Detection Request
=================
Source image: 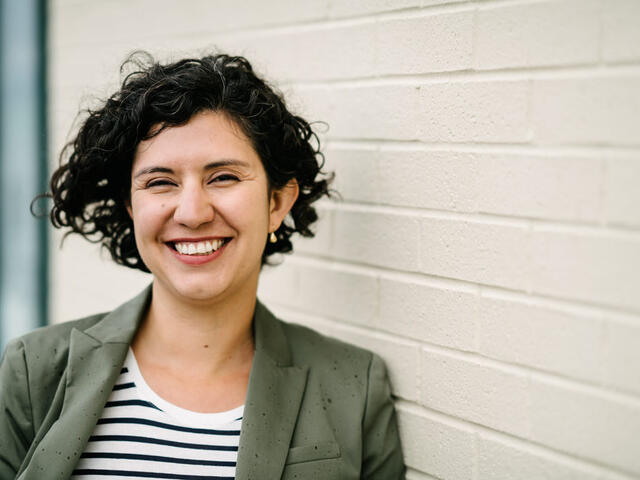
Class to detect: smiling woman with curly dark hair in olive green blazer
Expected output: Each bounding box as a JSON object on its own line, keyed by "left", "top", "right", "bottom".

{"left": 0, "top": 55, "right": 404, "bottom": 480}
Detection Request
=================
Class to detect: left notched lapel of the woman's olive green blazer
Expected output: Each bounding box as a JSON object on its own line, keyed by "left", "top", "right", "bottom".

{"left": 18, "top": 288, "right": 150, "bottom": 480}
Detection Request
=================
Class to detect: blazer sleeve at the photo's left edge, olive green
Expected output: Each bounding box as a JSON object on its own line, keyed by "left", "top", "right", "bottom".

{"left": 0, "top": 340, "right": 34, "bottom": 480}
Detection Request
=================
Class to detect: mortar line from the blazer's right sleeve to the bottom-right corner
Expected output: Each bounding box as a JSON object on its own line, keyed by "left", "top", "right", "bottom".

{"left": 395, "top": 399, "right": 637, "bottom": 480}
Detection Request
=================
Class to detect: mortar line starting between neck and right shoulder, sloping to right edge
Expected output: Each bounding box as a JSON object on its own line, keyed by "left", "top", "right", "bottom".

{"left": 273, "top": 301, "right": 640, "bottom": 409}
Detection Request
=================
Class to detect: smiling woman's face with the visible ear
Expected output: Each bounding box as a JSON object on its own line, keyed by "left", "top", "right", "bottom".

{"left": 128, "top": 111, "right": 298, "bottom": 302}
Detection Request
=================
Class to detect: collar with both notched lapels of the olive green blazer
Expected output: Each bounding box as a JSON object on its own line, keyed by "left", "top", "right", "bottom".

{"left": 18, "top": 286, "right": 307, "bottom": 480}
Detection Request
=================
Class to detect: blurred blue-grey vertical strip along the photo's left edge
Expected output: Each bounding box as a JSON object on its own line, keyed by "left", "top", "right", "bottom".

{"left": 0, "top": 0, "right": 47, "bottom": 346}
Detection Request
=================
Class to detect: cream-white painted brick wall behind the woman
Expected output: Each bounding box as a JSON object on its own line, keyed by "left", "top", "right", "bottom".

{"left": 49, "top": 0, "right": 640, "bottom": 480}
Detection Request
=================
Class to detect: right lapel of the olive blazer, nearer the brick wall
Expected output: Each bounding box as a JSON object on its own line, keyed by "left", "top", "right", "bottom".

{"left": 236, "top": 302, "right": 308, "bottom": 480}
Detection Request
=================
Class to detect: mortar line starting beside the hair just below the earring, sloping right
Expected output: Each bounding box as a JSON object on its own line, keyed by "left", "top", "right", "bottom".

{"left": 290, "top": 252, "right": 640, "bottom": 327}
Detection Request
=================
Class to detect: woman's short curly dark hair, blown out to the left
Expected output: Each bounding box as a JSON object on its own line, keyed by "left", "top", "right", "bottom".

{"left": 45, "top": 52, "right": 331, "bottom": 272}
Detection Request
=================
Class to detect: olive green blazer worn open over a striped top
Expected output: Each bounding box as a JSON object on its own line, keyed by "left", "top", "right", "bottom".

{"left": 0, "top": 288, "right": 404, "bottom": 480}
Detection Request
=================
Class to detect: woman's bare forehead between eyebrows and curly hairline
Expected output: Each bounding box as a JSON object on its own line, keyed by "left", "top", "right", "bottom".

{"left": 133, "top": 110, "right": 261, "bottom": 169}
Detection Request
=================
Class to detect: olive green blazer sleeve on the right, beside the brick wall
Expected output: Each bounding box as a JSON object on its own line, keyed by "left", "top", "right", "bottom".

{"left": 362, "top": 354, "right": 405, "bottom": 480}
